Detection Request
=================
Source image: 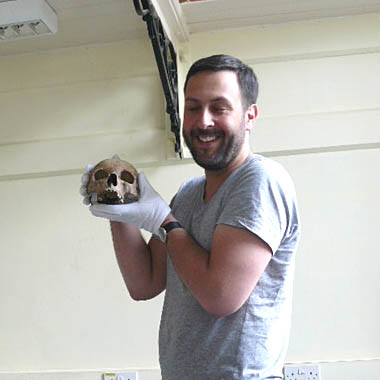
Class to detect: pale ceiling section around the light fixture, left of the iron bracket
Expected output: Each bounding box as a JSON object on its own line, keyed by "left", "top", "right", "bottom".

{"left": 0, "top": 0, "right": 147, "bottom": 56}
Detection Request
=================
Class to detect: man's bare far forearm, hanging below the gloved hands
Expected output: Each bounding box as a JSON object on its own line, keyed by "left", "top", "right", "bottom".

{"left": 111, "top": 222, "right": 166, "bottom": 300}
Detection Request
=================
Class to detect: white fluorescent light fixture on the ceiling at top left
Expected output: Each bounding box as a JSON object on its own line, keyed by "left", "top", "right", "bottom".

{"left": 0, "top": 0, "right": 57, "bottom": 42}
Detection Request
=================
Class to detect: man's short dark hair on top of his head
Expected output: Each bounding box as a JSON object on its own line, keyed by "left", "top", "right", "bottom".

{"left": 184, "top": 54, "right": 259, "bottom": 109}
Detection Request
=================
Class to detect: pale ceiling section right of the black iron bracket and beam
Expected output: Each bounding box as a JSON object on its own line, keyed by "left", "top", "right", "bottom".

{"left": 182, "top": 0, "right": 380, "bottom": 33}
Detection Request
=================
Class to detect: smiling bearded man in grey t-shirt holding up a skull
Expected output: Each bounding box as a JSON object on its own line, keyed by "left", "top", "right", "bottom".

{"left": 81, "top": 55, "right": 299, "bottom": 380}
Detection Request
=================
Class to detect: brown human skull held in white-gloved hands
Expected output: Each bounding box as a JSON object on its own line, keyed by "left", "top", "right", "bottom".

{"left": 87, "top": 157, "right": 139, "bottom": 205}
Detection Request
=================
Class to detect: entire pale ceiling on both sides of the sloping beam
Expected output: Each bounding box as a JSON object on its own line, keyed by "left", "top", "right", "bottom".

{"left": 0, "top": 0, "right": 380, "bottom": 56}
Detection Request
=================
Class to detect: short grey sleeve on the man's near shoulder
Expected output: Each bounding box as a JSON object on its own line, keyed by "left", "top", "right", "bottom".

{"left": 217, "top": 161, "right": 294, "bottom": 254}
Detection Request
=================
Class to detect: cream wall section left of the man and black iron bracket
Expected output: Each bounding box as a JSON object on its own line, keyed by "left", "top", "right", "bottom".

{"left": 0, "top": 37, "right": 175, "bottom": 378}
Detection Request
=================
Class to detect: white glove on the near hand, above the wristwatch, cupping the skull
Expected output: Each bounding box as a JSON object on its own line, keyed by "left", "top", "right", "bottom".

{"left": 90, "top": 173, "right": 171, "bottom": 234}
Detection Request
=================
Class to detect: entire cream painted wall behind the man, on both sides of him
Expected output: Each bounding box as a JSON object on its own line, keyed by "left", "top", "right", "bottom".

{"left": 0, "top": 10, "right": 380, "bottom": 380}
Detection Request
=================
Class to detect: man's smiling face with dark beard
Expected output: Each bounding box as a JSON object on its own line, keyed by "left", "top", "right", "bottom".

{"left": 183, "top": 71, "right": 248, "bottom": 170}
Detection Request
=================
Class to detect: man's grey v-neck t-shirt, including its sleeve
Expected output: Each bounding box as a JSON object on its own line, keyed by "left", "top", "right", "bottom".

{"left": 159, "top": 155, "right": 299, "bottom": 380}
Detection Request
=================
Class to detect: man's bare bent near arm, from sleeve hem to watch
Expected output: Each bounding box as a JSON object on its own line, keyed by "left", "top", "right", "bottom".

{"left": 168, "top": 215, "right": 272, "bottom": 317}
